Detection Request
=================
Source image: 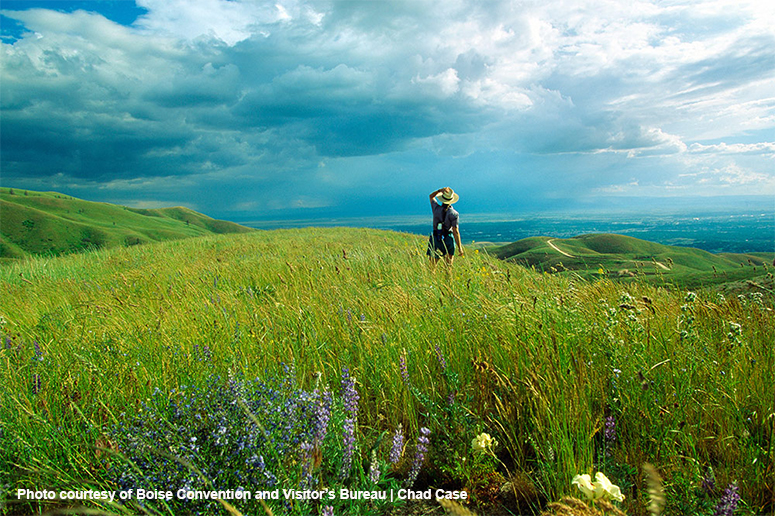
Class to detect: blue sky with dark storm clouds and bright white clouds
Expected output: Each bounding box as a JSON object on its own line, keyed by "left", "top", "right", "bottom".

{"left": 0, "top": 0, "right": 775, "bottom": 221}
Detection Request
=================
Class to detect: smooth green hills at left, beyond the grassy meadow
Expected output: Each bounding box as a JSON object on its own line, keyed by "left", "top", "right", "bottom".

{"left": 0, "top": 188, "right": 252, "bottom": 260}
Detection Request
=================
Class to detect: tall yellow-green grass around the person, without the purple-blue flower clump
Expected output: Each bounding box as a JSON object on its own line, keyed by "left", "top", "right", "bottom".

{"left": 0, "top": 229, "right": 775, "bottom": 513}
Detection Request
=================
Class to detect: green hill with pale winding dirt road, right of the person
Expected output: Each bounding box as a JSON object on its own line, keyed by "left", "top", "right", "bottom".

{"left": 486, "top": 234, "right": 775, "bottom": 288}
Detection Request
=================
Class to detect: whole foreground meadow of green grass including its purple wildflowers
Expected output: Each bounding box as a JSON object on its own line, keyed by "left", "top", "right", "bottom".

{"left": 0, "top": 228, "right": 775, "bottom": 515}
